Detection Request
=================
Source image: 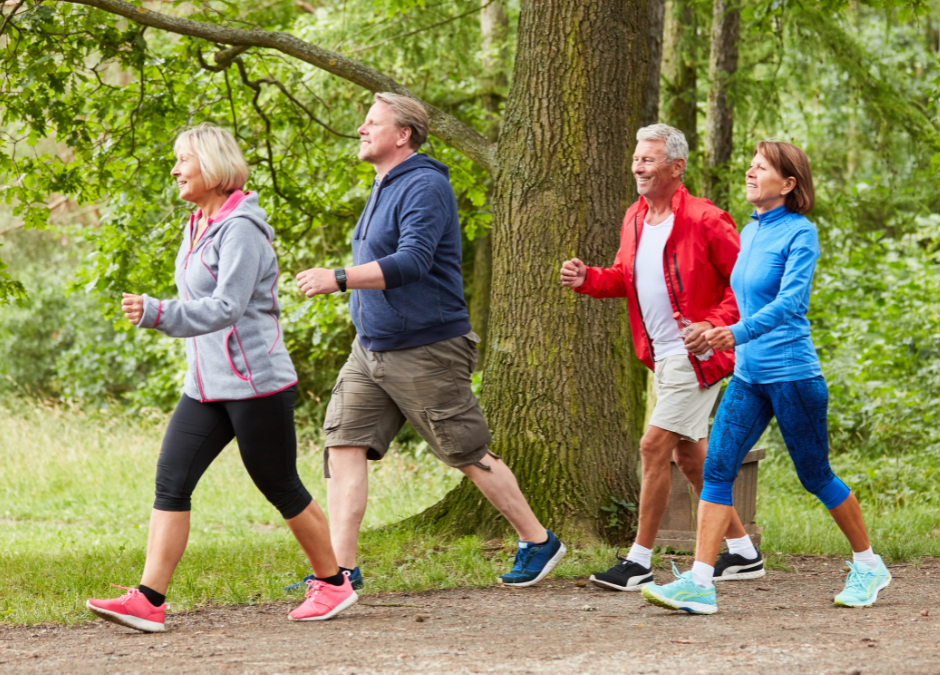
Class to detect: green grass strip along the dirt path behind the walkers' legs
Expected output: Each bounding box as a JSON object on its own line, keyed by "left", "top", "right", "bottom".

{"left": 0, "top": 402, "right": 940, "bottom": 624}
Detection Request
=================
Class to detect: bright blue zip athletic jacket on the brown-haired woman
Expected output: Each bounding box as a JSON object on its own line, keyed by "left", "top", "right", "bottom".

{"left": 729, "top": 206, "right": 822, "bottom": 384}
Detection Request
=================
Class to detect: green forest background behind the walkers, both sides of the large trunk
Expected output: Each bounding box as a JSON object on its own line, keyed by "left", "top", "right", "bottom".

{"left": 0, "top": 0, "right": 940, "bottom": 624}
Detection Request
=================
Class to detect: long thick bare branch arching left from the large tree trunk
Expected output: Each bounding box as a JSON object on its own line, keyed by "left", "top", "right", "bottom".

{"left": 58, "top": 0, "right": 496, "bottom": 173}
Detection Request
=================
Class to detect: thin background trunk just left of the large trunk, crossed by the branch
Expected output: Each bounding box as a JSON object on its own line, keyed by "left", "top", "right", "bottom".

{"left": 470, "top": 0, "right": 509, "bottom": 369}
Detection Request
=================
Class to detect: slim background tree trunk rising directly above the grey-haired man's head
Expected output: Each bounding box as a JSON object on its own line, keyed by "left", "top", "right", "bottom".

{"left": 659, "top": 0, "right": 698, "bottom": 154}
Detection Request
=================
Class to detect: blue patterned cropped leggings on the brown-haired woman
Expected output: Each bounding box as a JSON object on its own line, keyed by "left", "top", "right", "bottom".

{"left": 701, "top": 376, "right": 851, "bottom": 509}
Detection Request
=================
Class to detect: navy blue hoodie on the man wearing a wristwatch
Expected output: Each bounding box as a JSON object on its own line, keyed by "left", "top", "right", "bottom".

{"left": 349, "top": 154, "right": 470, "bottom": 352}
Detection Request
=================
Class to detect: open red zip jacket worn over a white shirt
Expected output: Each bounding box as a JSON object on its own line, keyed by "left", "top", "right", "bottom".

{"left": 575, "top": 185, "right": 741, "bottom": 388}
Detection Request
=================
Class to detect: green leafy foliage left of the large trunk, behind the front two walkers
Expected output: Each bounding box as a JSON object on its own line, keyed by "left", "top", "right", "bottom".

{"left": 0, "top": 0, "right": 500, "bottom": 416}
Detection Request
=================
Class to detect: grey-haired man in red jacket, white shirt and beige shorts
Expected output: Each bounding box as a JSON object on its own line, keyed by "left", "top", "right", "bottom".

{"left": 561, "top": 124, "right": 764, "bottom": 591}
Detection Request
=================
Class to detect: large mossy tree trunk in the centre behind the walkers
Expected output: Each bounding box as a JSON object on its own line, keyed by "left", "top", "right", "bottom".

{"left": 419, "top": 0, "right": 647, "bottom": 542}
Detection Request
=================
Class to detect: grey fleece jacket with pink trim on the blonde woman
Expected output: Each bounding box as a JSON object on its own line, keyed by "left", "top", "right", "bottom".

{"left": 138, "top": 190, "right": 297, "bottom": 402}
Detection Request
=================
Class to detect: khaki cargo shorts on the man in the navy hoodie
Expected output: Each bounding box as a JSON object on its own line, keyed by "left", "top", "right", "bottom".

{"left": 323, "top": 333, "right": 495, "bottom": 478}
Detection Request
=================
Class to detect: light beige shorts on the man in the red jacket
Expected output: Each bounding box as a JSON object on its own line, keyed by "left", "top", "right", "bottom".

{"left": 650, "top": 355, "right": 721, "bottom": 443}
